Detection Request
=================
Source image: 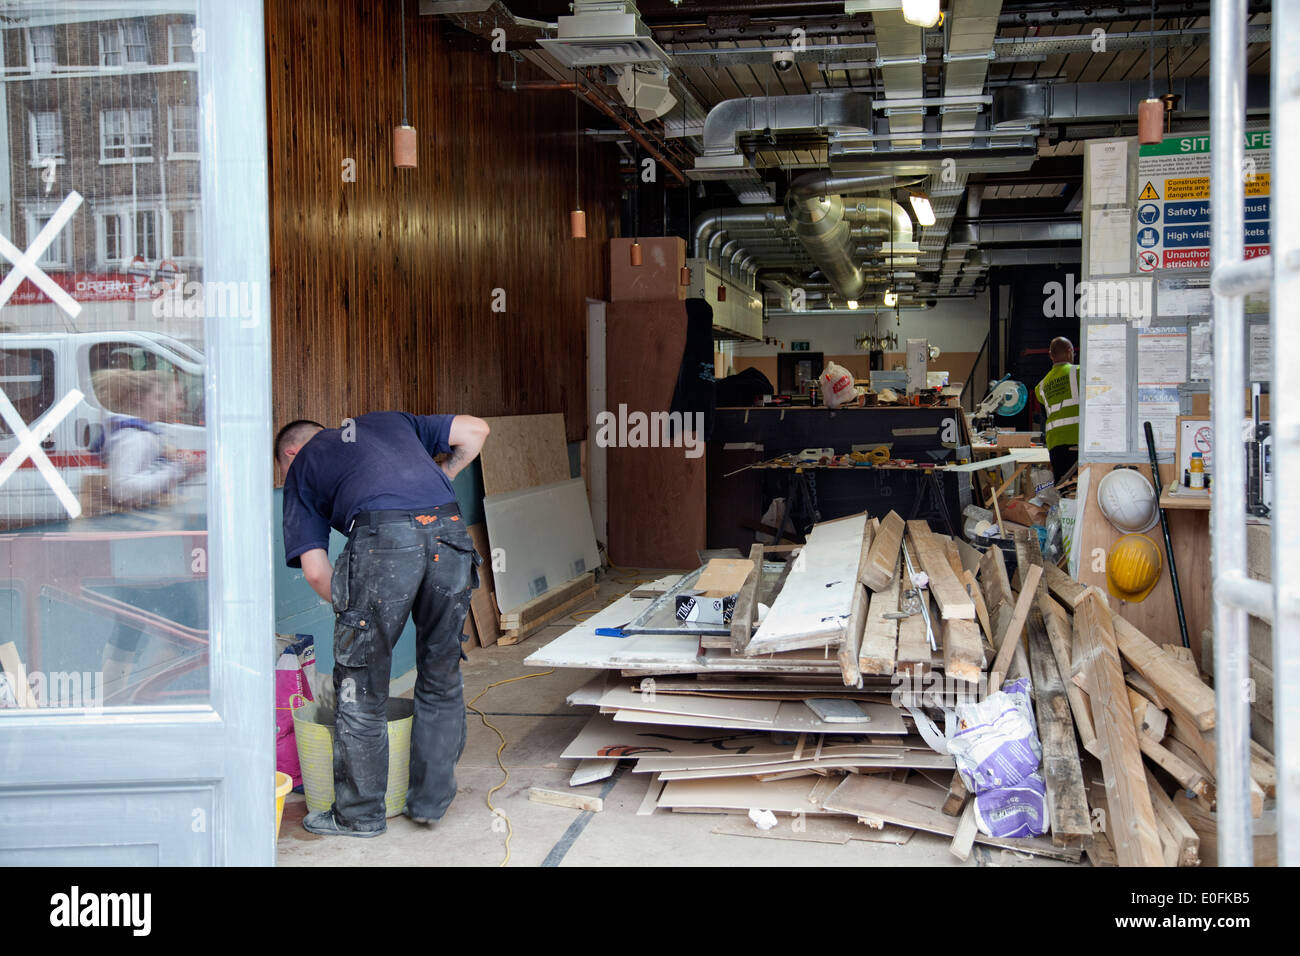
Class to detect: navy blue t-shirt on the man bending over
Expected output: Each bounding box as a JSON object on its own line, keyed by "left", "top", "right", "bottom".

{"left": 285, "top": 411, "right": 456, "bottom": 567}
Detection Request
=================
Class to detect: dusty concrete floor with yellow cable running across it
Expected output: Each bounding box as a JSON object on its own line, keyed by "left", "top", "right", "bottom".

{"left": 271, "top": 580, "right": 1066, "bottom": 866}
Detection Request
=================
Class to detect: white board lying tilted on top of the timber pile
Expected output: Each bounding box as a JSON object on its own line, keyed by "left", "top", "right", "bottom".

{"left": 746, "top": 515, "right": 867, "bottom": 654}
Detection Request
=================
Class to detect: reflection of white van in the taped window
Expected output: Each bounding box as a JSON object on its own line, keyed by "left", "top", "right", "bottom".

{"left": 0, "top": 332, "right": 207, "bottom": 528}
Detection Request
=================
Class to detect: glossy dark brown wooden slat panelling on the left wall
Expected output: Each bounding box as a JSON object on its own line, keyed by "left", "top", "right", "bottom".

{"left": 265, "top": 0, "right": 616, "bottom": 441}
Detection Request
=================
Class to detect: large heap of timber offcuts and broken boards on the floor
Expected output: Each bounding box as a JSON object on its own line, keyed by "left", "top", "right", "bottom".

{"left": 525, "top": 512, "right": 1271, "bottom": 865}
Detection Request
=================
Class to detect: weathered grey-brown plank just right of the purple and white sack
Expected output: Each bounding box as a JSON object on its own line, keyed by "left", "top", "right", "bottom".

{"left": 1027, "top": 607, "right": 1092, "bottom": 847}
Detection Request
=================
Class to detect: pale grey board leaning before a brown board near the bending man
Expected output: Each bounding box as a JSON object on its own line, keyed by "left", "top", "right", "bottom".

{"left": 484, "top": 479, "right": 601, "bottom": 614}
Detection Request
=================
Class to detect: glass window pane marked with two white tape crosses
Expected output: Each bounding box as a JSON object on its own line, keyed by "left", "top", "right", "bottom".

{"left": 0, "top": 3, "right": 209, "bottom": 718}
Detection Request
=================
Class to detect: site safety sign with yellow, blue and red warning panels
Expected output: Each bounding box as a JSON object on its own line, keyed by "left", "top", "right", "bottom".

{"left": 1134, "top": 130, "right": 1273, "bottom": 272}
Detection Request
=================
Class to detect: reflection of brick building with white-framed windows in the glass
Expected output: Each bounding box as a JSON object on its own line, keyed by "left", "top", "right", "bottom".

{"left": 0, "top": 13, "right": 202, "bottom": 304}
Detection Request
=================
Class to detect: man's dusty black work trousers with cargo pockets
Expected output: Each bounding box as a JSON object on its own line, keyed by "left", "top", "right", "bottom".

{"left": 330, "top": 505, "right": 481, "bottom": 830}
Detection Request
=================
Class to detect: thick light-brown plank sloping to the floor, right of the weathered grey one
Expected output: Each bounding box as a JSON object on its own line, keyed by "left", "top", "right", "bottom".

{"left": 1071, "top": 590, "right": 1164, "bottom": 866}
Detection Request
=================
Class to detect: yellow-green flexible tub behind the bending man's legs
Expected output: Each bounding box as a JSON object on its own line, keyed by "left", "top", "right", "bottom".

{"left": 294, "top": 697, "right": 415, "bottom": 817}
